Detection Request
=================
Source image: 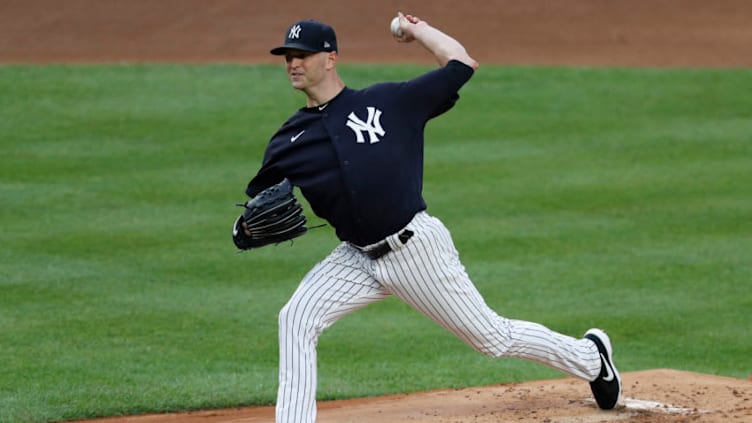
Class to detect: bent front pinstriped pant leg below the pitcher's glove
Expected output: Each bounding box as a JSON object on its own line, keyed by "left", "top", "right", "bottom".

{"left": 276, "top": 244, "right": 389, "bottom": 423}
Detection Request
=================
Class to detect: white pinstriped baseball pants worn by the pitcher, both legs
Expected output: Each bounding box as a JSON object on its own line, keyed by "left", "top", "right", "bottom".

{"left": 276, "top": 212, "right": 601, "bottom": 423}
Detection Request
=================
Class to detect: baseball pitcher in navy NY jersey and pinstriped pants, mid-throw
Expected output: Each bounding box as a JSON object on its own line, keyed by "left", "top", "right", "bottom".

{"left": 233, "top": 13, "right": 621, "bottom": 423}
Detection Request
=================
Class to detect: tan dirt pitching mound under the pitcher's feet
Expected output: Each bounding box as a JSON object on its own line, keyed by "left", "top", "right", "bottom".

{"left": 78, "top": 369, "right": 752, "bottom": 423}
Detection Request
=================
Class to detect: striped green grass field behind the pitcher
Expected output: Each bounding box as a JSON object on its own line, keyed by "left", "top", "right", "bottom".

{"left": 0, "top": 65, "right": 752, "bottom": 423}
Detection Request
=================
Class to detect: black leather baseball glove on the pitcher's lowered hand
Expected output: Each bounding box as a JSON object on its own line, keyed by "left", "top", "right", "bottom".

{"left": 232, "top": 179, "right": 308, "bottom": 250}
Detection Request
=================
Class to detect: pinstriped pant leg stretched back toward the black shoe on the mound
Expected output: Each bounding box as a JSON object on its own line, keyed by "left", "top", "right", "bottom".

{"left": 376, "top": 213, "right": 601, "bottom": 380}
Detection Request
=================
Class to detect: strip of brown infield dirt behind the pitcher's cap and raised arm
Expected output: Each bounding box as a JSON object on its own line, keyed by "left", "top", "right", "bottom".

{"left": 0, "top": 0, "right": 752, "bottom": 67}
